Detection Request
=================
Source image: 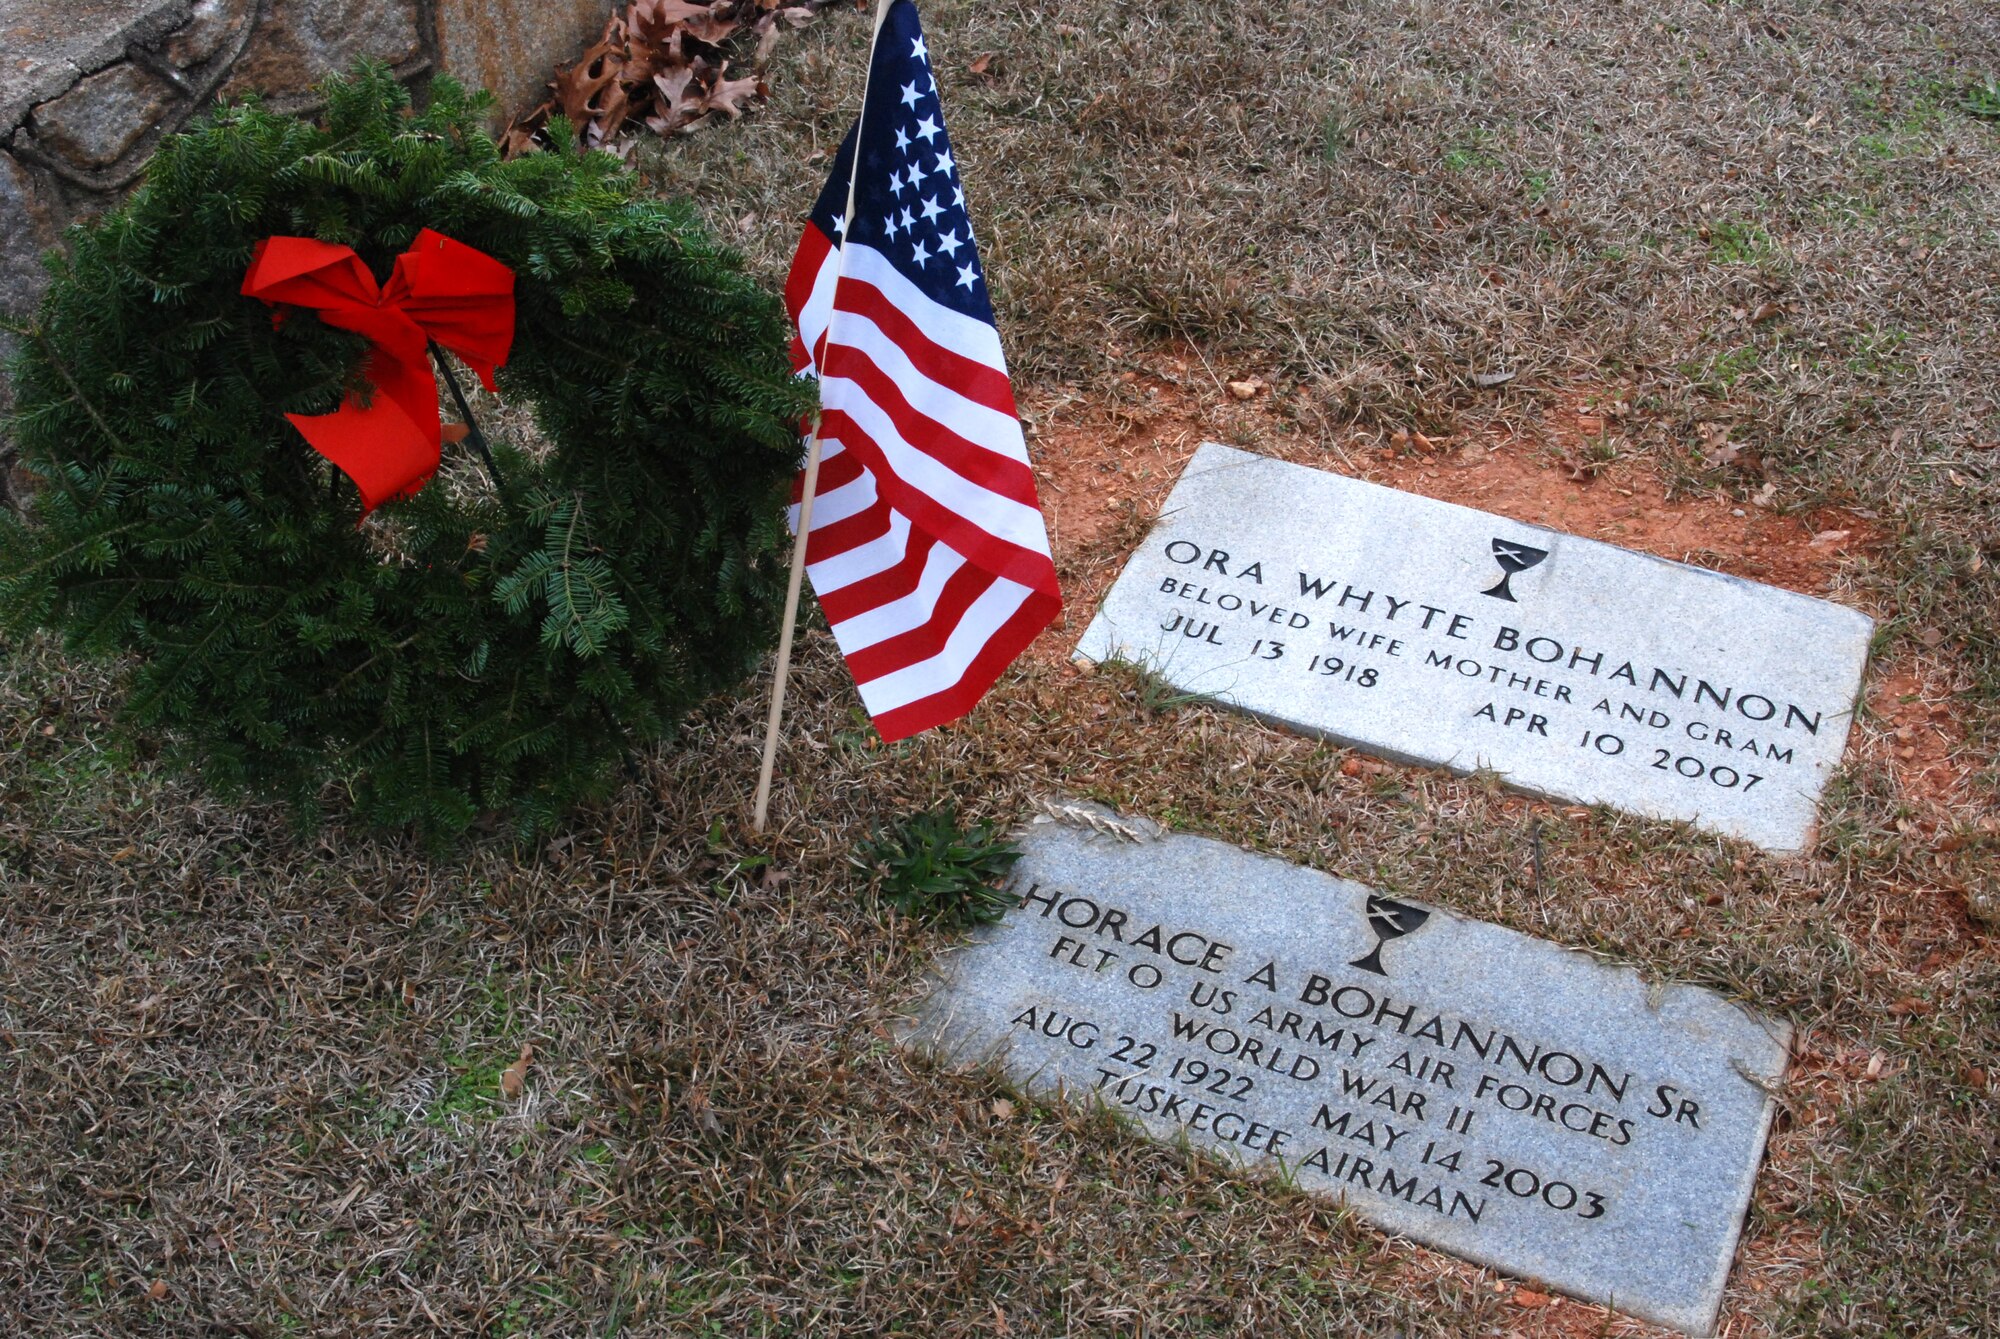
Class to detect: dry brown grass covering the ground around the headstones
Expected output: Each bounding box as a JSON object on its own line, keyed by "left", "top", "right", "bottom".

{"left": 0, "top": 0, "right": 2000, "bottom": 1337}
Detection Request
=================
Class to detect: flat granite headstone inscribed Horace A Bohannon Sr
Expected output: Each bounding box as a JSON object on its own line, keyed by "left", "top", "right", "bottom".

{"left": 904, "top": 819, "right": 1790, "bottom": 1335}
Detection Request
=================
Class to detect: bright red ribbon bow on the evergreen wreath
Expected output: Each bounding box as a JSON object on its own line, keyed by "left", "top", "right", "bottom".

{"left": 242, "top": 228, "right": 514, "bottom": 516}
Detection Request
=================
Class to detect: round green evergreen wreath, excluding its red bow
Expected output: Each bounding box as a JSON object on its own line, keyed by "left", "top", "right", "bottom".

{"left": 0, "top": 66, "right": 806, "bottom": 839}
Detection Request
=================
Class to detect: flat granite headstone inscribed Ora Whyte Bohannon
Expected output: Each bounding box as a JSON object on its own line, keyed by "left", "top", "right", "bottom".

{"left": 1076, "top": 444, "right": 1874, "bottom": 851}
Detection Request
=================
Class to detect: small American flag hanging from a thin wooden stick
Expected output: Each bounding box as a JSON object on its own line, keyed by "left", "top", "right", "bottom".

{"left": 784, "top": 0, "right": 1062, "bottom": 739}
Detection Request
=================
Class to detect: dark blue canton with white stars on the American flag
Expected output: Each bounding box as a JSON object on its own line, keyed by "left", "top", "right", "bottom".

{"left": 812, "top": 0, "right": 994, "bottom": 324}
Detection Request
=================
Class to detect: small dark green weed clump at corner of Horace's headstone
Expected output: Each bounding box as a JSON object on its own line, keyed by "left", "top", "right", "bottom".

{"left": 854, "top": 803, "right": 1020, "bottom": 929}
